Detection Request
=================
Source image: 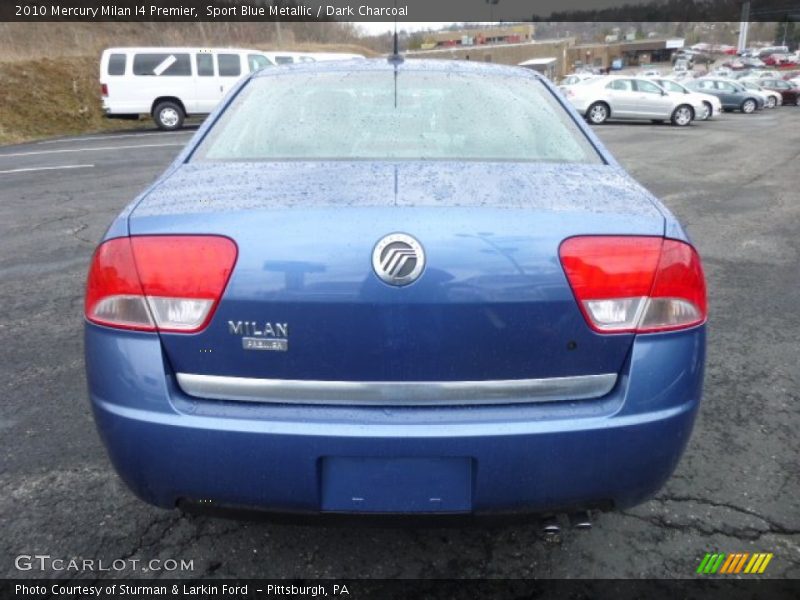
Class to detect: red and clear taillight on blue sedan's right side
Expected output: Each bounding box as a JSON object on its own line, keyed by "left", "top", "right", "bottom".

{"left": 559, "top": 236, "right": 707, "bottom": 333}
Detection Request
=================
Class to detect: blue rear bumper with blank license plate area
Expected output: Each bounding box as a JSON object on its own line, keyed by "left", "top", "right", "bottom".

{"left": 86, "top": 325, "right": 705, "bottom": 515}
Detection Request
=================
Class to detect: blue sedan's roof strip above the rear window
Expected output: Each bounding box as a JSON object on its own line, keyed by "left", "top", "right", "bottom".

{"left": 251, "top": 58, "right": 544, "bottom": 80}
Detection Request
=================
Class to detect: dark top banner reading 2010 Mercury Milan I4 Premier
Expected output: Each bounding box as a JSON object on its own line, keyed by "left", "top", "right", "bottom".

{"left": 0, "top": 0, "right": 800, "bottom": 22}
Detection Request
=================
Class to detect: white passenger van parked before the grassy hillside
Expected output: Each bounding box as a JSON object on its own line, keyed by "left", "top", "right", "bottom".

{"left": 100, "top": 47, "right": 314, "bottom": 131}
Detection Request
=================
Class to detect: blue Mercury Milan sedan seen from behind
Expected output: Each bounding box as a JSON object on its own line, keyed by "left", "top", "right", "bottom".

{"left": 85, "top": 59, "right": 706, "bottom": 515}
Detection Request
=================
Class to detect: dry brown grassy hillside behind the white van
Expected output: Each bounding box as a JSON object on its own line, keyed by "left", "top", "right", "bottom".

{"left": 0, "top": 23, "right": 374, "bottom": 144}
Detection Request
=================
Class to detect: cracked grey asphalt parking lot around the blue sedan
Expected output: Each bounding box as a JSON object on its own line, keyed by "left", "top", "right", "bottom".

{"left": 0, "top": 107, "right": 800, "bottom": 578}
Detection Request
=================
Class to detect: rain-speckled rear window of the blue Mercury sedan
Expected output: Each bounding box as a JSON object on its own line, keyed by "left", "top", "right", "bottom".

{"left": 194, "top": 71, "right": 602, "bottom": 163}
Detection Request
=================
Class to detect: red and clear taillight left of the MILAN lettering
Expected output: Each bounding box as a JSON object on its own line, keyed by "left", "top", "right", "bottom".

{"left": 85, "top": 235, "right": 237, "bottom": 333}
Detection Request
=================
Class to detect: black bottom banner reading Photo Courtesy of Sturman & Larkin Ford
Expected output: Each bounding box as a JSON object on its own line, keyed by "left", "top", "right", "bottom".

{"left": 0, "top": 577, "right": 800, "bottom": 600}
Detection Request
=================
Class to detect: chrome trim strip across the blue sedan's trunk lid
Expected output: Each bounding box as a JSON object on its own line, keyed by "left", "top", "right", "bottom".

{"left": 177, "top": 373, "right": 617, "bottom": 406}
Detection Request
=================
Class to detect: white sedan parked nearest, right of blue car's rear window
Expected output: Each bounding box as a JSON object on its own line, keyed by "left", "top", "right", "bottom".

{"left": 565, "top": 75, "right": 704, "bottom": 127}
